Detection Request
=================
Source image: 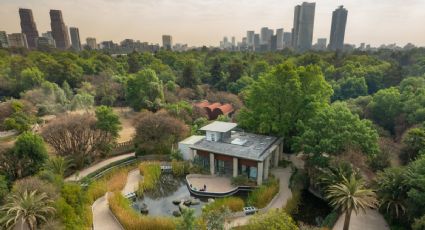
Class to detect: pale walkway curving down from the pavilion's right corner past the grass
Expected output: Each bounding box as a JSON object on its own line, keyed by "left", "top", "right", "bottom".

{"left": 225, "top": 167, "right": 292, "bottom": 229}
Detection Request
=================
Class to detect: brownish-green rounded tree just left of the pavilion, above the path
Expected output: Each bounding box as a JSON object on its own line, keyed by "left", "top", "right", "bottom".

{"left": 135, "top": 111, "right": 189, "bottom": 154}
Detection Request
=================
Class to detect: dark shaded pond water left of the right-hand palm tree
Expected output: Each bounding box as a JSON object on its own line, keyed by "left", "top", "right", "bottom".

{"left": 293, "top": 190, "right": 332, "bottom": 226}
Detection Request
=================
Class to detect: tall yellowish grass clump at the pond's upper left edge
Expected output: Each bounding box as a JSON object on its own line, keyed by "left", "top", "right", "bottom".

{"left": 137, "top": 162, "right": 161, "bottom": 196}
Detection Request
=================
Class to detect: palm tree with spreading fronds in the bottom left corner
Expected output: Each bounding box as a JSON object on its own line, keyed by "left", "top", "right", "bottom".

{"left": 0, "top": 190, "right": 55, "bottom": 230}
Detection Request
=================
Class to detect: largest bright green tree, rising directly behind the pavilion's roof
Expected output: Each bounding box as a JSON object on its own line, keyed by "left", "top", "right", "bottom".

{"left": 238, "top": 63, "right": 332, "bottom": 147}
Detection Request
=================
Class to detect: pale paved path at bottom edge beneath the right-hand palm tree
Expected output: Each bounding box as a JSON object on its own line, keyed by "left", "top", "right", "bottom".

{"left": 333, "top": 209, "right": 390, "bottom": 230}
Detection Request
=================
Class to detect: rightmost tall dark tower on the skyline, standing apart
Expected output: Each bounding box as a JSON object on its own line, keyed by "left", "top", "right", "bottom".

{"left": 329, "top": 6, "right": 348, "bottom": 50}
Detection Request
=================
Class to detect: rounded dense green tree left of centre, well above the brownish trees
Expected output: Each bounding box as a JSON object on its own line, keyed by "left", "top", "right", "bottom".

{"left": 126, "top": 69, "right": 164, "bottom": 111}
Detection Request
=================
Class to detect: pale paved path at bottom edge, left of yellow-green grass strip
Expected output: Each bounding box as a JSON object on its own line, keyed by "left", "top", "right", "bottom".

{"left": 92, "top": 195, "right": 123, "bottom": 230}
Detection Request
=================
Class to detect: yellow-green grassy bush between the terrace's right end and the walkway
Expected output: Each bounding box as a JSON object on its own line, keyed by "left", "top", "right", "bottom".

{"left": 247, "top": 178, "right": 279, "bottom": 208}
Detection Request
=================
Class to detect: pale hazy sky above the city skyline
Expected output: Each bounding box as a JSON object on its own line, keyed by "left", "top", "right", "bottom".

{"left": 0, "top": 0, "right": 425, "bottom": 46}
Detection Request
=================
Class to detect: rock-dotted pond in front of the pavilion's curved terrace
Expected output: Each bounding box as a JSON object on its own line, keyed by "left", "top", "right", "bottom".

{"left": 132, "top": 174, "right": 207, "bottom": 216}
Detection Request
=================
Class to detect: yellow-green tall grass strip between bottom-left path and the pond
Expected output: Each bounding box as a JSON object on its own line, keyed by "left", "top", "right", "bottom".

{"left": 108, "top": 192, "right": 176, "bottom": 230}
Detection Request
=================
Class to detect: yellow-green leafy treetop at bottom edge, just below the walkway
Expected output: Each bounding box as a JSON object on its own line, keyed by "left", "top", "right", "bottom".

{"left": 246, "top": 209, "right": 298, "bottom": 230}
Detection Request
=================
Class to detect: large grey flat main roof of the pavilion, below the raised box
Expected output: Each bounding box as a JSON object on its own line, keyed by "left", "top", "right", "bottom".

{"left": 190, "top": 131, "right": 280, "bottom": 161}
